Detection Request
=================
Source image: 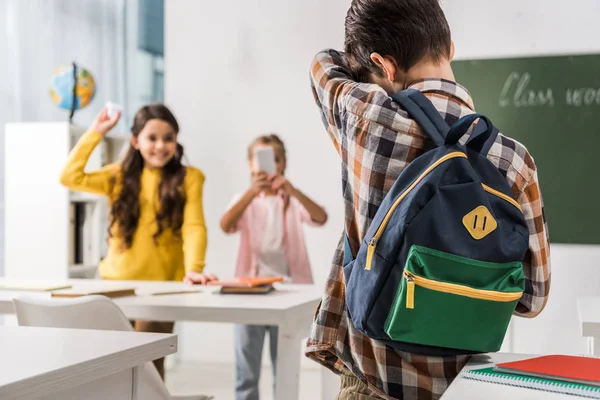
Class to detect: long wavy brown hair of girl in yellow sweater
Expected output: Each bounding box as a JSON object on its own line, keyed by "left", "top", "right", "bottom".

{"left": 108, "top": 104, "right": 186, "bottom": 249}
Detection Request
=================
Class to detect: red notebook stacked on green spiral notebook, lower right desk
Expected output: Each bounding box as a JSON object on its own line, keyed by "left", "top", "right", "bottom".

{"left": 461, "top": 355, "right": 600, "bottom": 399}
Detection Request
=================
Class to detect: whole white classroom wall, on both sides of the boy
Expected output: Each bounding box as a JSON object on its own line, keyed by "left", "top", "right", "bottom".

{"left": 165, "top": 0, "right": 600, "bottom": 367}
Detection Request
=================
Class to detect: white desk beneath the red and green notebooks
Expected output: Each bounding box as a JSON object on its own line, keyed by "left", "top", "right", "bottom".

{"left": 441, "top": 353, "right": 579, "bottom": 400}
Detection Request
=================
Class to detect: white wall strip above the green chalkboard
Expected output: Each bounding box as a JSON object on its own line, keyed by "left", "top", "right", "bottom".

{"left": 442, "top": 0, "right": 600, "bottom": 59}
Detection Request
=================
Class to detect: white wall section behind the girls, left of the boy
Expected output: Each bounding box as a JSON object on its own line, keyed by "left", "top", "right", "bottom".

{"left": 165, "top": 0, "right": 346, "bottom": 365}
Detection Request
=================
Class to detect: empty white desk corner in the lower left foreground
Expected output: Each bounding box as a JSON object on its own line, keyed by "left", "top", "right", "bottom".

{"left": 0, "top": 326, "right": 177, "bottom": 400}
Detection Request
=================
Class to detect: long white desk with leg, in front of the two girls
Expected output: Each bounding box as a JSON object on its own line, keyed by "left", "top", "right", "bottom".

{"left": 0, "top": 279, "right": 323, "bottom": 400}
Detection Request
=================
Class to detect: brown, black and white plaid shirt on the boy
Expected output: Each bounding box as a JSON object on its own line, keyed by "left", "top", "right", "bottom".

{"left": 306, "top": 50, "right": 550, "bottom": 399}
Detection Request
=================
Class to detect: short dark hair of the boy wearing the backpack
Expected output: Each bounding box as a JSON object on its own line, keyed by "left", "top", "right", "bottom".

{"left": 344, "top": 0, "right": 451, "bottom": 81}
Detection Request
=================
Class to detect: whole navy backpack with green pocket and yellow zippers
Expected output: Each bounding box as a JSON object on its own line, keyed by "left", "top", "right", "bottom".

{"left": 343, "top": 89, "right": 529, "bottom": 356}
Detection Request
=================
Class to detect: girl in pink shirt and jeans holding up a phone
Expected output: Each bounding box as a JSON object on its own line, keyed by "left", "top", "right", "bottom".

{"left": 221, "top": 135, "right": 327, "bottom": 400}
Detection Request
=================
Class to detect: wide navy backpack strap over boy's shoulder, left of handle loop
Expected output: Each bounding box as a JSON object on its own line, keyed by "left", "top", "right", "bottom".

{"left": 392, "top": 89, "right": 450, "bottom": 146}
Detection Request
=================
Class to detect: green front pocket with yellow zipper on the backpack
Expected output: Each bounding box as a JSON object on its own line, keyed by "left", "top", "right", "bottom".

{"left": 385, "top": 246, "right": 525, "bottom": 352}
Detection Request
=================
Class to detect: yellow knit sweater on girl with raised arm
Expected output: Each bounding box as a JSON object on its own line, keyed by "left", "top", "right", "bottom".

{"left": 60, "top": 131, "right": 207, "bottom": 281}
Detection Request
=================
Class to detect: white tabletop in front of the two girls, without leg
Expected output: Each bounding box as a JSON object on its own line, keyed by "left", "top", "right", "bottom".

{"left": 0, "top": 279, "right": 323, "bottom": 324}
